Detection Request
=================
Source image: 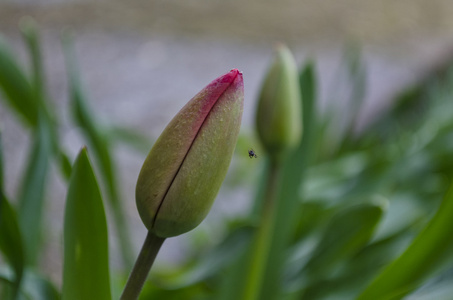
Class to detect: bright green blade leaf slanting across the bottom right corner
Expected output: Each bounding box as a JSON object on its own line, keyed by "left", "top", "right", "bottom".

{"left": 357, "top": 180, "right": 453, "bottom": 300}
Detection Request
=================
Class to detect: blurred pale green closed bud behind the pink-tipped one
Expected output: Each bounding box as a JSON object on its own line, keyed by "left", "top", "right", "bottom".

{"left": 256, "top": 45, "right": 302, "bottom": 160}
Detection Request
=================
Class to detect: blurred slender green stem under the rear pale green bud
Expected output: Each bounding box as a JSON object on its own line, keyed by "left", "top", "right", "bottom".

{"left": 242, "top": 162, "right": 280, "bottom": 300}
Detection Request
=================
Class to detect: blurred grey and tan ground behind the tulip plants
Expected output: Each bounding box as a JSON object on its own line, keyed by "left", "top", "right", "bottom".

{"left": 0, "top": 0, "right": 453, "bottom": 282}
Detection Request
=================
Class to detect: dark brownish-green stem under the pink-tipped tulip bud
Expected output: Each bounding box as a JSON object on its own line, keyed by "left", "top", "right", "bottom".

{"left": 120, "top": 232, "right": 165, "bottom": 300}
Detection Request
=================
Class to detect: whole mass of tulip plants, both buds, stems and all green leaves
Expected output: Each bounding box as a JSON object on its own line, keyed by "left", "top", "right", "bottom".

{"left": 0, "top": 20, "right": 453, "bottom": 300}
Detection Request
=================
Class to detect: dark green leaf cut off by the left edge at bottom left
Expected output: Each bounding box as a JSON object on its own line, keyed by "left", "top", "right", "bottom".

{"left": 0, "top": 193, "right": 25, "bottom": 299}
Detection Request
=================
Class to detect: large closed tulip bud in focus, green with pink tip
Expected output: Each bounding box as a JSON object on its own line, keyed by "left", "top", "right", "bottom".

{"left": 136, "top": 69, "right": 244, "bottom": 238}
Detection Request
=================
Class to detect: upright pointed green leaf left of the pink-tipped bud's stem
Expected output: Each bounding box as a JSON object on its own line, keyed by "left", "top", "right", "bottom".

{"left": 63, "top": 148, "right": 111, "bottom": 300}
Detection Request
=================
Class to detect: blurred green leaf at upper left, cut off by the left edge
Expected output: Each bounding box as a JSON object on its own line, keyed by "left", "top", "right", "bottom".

{"left": 0, "top": 36, "right": 38, "bottom": 126}
